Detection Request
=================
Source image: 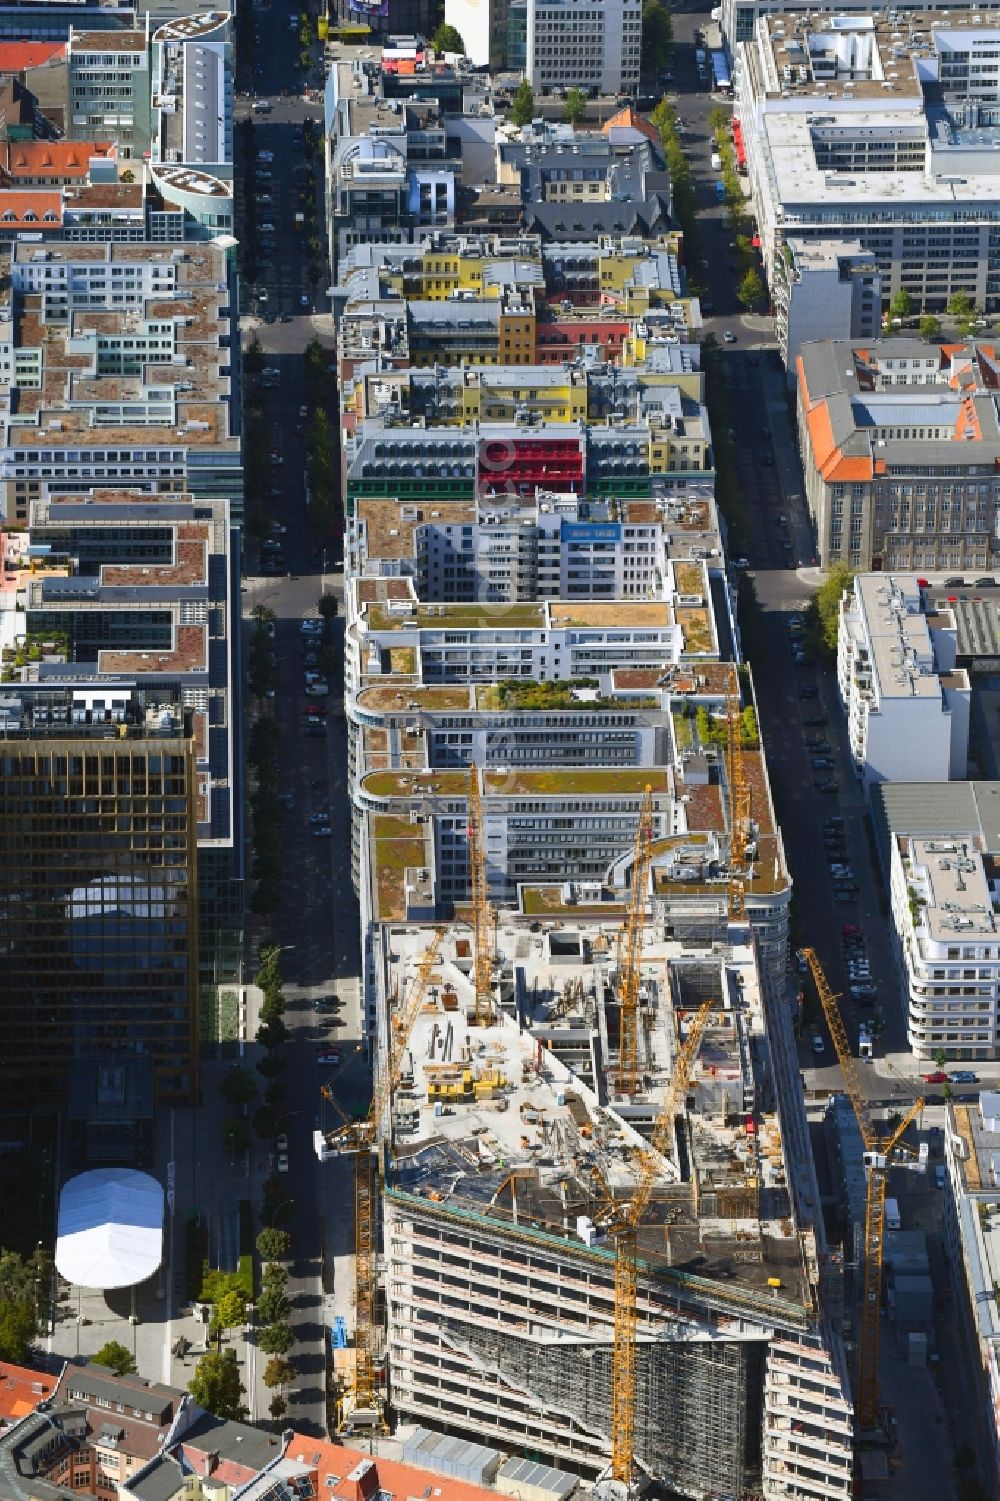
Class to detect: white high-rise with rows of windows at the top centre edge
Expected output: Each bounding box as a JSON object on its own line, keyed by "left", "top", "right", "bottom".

{"left": 524, "top": 0, "right": 643, "bottom": 95}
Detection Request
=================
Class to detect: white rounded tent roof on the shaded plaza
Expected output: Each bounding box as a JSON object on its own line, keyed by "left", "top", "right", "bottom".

{"left": 56, "top": 1168, "right": 164, "bottom": 1289}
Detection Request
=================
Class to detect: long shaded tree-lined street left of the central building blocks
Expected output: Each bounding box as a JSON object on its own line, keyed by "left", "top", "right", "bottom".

{"left": 237, "top": 6, "right": 371, "bottom": 1435}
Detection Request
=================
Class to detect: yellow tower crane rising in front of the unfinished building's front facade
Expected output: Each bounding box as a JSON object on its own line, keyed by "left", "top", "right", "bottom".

{"left": 599, "top": 1000, "right": 719, "bottom": 1490}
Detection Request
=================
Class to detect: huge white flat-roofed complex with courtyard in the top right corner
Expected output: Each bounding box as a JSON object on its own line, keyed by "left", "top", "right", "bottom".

{"left": 736, "top": 8, "right": 1000, "bottom": 312}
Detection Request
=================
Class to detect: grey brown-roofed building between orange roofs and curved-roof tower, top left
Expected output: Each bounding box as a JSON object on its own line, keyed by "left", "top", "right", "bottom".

{"left": 66, "top": 27, "right": 150, "bottom": 162}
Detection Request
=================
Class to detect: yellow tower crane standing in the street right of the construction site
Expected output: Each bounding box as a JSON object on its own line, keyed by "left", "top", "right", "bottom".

{"left": 802, "top": 949, "right": 923, "bottom": 1429}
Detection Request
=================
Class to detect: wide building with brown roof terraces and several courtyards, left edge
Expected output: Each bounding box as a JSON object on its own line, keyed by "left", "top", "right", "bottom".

{"left": 0, "top": 242, "right": 242, "bottom": 524}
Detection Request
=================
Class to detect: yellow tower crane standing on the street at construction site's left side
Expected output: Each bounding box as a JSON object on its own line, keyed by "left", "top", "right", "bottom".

{"left": 326, "top": 928, "right": 444, "bottom": 1426}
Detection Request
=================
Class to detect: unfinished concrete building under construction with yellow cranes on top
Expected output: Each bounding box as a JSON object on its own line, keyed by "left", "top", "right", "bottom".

{"left": 317, "top": 904, "right": 853, "bottom": 1501}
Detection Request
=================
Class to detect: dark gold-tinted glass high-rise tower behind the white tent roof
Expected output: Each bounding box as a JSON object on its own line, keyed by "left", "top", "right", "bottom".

{"left": 0, "top": 714, "right": 198, "bottom": 1105}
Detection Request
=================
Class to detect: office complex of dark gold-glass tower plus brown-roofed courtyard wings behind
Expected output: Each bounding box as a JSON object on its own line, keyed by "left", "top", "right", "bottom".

{"left": 0, "top": 491, "right": 243, "bottom": 1099}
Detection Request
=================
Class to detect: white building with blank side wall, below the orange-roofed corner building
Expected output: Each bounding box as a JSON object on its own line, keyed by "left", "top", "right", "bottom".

{"left": 836, "top": 573, "right": 970, "bottom": 796}
